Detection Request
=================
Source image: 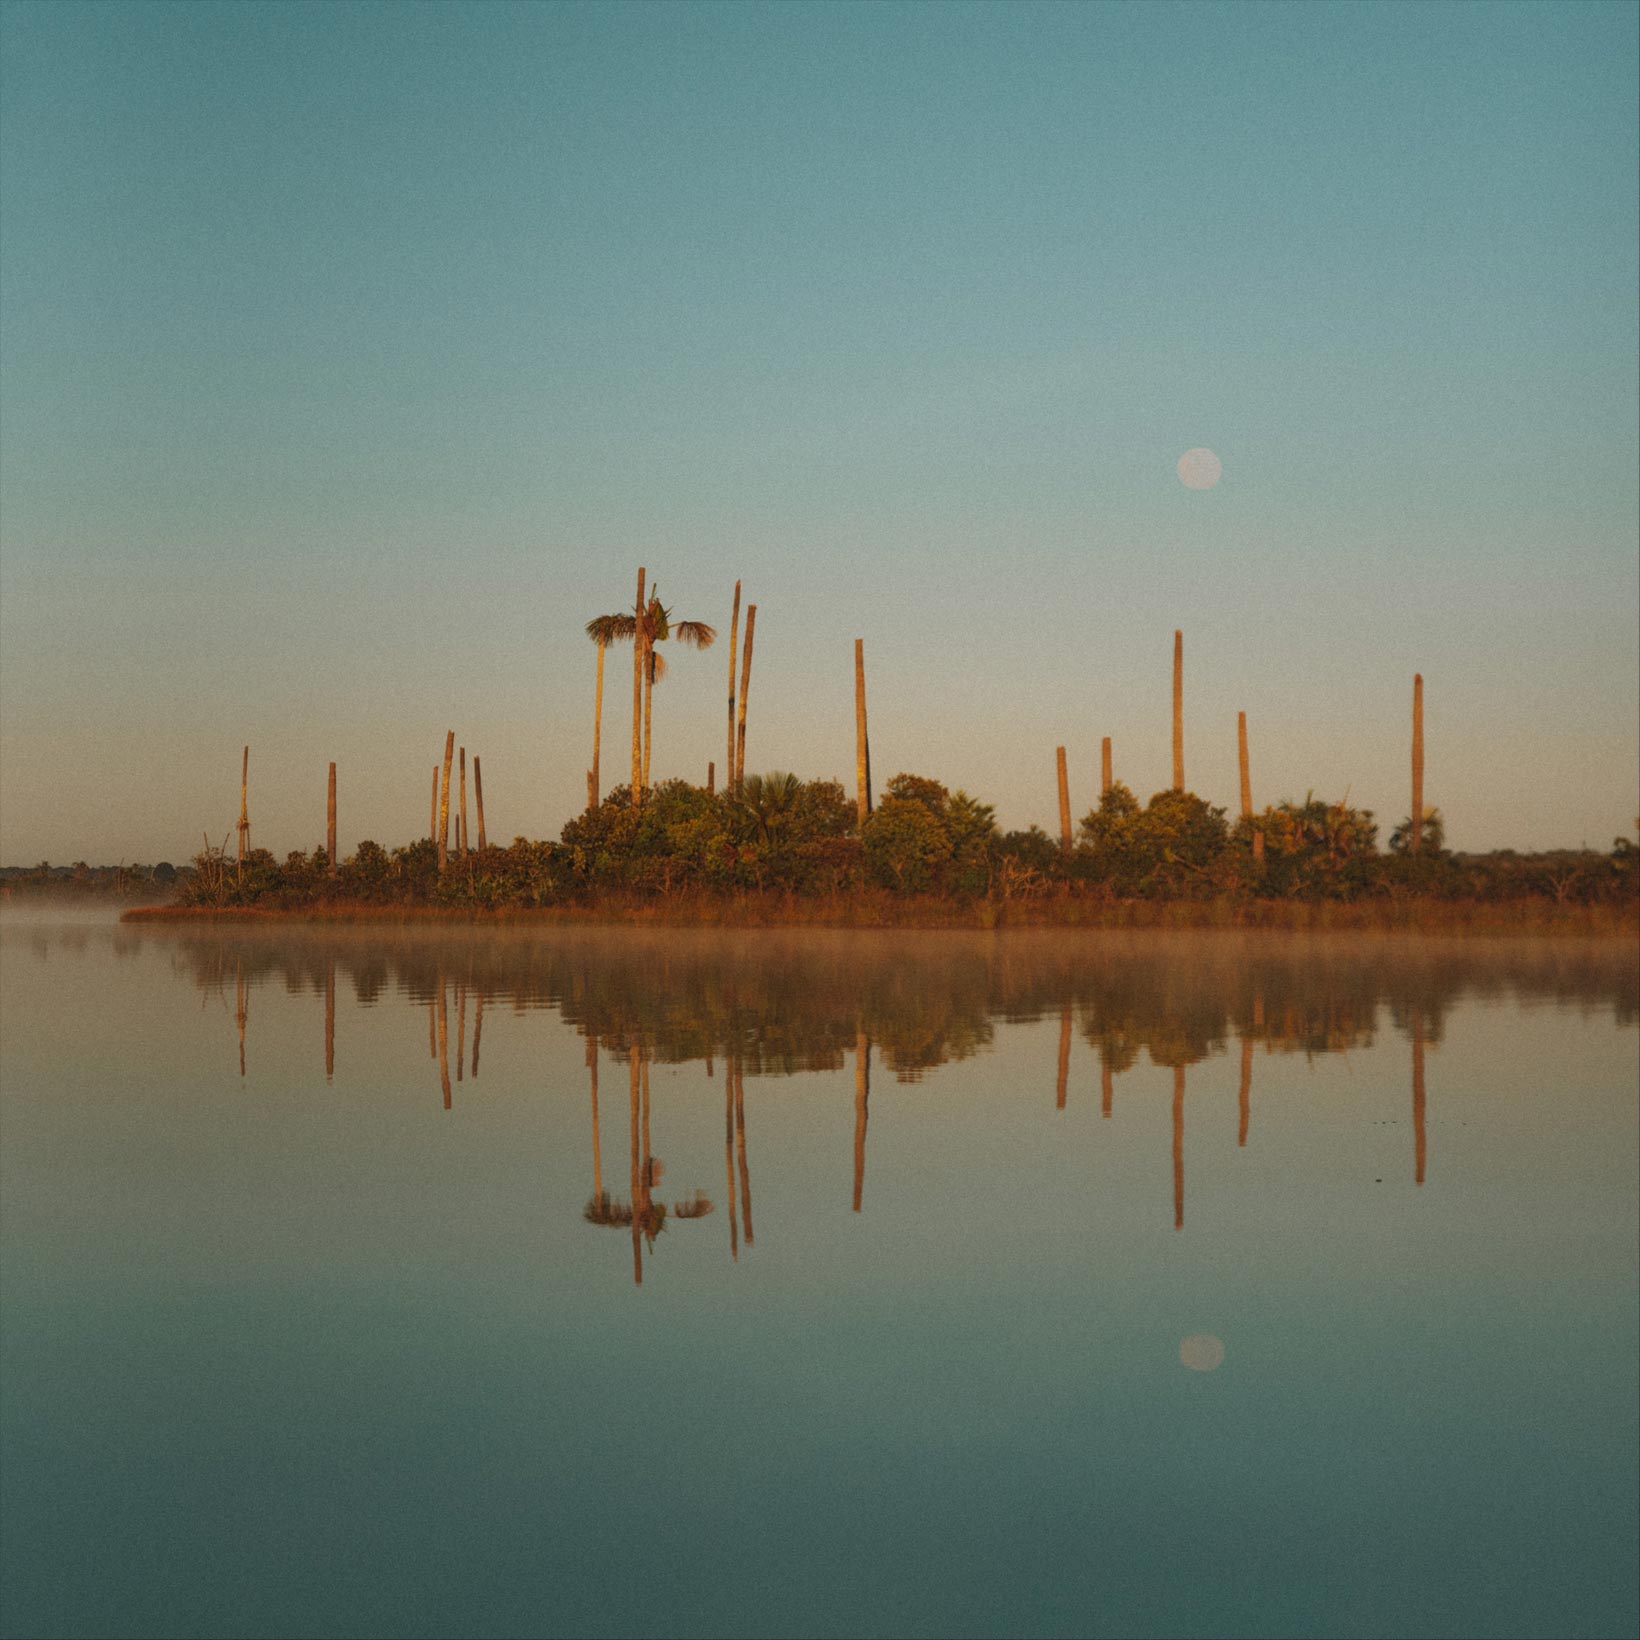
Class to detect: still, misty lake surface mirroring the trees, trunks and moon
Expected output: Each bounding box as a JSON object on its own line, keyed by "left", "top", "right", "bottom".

{"left": 0, "top": 918, "right": 1640, "bottom": 1635}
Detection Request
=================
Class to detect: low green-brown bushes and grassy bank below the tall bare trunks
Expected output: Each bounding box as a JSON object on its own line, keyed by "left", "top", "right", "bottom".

{"left": 137, "top": 774, "right": 1640, "bottom": 922}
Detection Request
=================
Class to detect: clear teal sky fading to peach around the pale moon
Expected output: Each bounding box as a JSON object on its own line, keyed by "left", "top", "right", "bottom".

{"left": 0, "top": 0, "right": 1640, "bottom": 864}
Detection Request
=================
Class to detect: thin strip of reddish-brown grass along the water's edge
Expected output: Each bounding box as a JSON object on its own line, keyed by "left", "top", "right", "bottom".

{"left": 120, "top": 895, "right": 1640, "bottom": 938}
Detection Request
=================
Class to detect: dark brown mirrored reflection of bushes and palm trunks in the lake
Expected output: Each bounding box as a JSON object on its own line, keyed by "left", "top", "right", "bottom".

{"left": 44, "top": 928, "right": 1640, "bottom": 1282}
